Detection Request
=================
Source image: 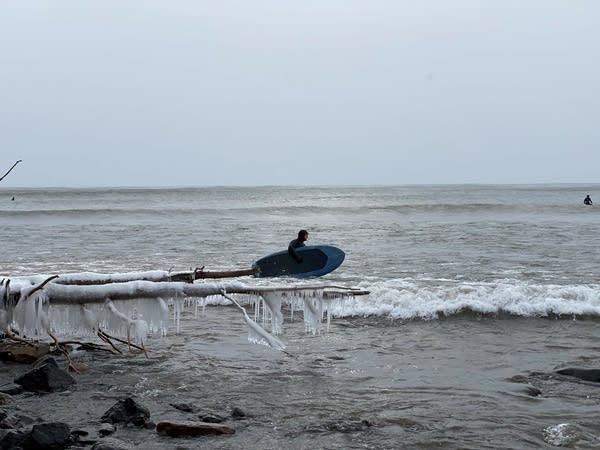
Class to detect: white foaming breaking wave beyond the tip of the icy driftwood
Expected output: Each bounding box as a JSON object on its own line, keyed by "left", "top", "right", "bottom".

{"left": 331, "top": 279, "right": 600, "bottom": 320}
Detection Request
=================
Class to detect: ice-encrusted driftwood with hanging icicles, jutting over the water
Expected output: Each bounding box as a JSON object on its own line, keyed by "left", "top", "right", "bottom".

{"left": 0, "top": 271, "right": 368, "bottom": 349}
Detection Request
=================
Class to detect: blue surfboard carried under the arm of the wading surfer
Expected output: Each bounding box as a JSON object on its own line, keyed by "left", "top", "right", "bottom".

{"left": 252, "top": 245, "right": 346, "bottom": 278}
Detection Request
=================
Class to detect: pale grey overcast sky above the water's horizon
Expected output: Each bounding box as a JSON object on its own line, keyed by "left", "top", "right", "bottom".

{"left": 0, "top": 0, "right": 600, "bottom": 188}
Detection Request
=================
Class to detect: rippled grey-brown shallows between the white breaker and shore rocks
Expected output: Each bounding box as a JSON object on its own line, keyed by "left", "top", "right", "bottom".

{"left": 2, "top": 307, "right": 600, "bottom": 449}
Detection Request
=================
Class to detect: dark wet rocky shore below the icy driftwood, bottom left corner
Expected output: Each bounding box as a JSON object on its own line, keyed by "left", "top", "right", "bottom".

{"left": 0, "top": 355, "right": 246, "bottom": 450}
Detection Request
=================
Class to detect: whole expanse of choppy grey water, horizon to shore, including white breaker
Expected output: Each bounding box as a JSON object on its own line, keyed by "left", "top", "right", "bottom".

{"left": 0, "top": 186, "right": 600, "bottom": 448}
